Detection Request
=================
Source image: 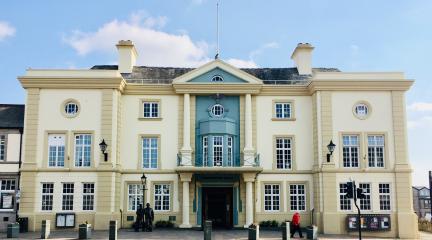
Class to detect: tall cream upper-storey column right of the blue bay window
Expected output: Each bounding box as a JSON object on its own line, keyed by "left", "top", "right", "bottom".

{"left": 243, "top": 93, "right": 254, "bottom": 166}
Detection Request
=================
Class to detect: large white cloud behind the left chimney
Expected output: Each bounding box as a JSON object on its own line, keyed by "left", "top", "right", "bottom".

{"left": 64, "top": 11, "right": 210, "bottom": 67}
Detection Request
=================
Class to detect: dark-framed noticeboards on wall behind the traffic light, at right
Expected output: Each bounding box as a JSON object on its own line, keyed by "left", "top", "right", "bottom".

{"left": 346, "top": 214, "right": 391, "bottom": 232}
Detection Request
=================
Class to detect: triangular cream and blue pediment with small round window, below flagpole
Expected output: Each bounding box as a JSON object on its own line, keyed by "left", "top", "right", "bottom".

{"left": 173, "top": 59, "right": 262, "bottom": 84}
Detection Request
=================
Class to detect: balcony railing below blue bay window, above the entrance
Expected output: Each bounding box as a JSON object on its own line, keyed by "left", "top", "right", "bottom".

{"left": 177, "top": 153, "right": 260, "bottom": 167}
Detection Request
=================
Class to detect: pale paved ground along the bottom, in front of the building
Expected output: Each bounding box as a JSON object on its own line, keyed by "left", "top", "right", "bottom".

{"left": 0, "top": 229, "right": 432, "bottom": 240}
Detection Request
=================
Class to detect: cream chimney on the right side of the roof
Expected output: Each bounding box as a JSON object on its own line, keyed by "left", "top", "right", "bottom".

{"left": 291, "top": 43, "right": 314, "bottom": 75}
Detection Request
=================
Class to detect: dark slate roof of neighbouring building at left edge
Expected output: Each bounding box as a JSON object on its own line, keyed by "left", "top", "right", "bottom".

{"left": 0, "top": 104, "right": 25, "bottom": 128}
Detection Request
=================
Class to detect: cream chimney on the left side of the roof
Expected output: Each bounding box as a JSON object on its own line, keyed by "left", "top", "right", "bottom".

{"left": 116, "top": 40, "right": 138, "bottom": 73}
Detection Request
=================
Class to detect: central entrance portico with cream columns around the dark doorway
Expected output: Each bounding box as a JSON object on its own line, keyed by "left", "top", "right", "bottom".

{"left": 176, "top": 171, "right": 262, "bottom": 229}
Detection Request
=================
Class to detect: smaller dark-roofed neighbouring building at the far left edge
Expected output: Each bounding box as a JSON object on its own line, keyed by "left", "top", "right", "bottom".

{"left": 0, "top": 104, "right": 24, "bottom": 231}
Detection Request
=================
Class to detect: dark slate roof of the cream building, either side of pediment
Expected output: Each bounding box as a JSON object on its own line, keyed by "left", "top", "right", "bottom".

{"left": 91, "top": 65, "right": 339, "bottom": 84}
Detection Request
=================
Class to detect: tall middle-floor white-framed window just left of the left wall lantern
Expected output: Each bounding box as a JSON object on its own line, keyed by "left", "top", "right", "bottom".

{"left": 75, "top": 134, "right": 92, "bottom": 167}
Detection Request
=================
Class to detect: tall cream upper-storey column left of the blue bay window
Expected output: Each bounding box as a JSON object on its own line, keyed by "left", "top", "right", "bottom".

{"left": 180, "top": 93, "right": 192, "bottom": 165}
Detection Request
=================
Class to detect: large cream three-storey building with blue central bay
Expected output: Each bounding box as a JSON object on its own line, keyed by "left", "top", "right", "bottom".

{"left": 19, "top": 41, "right": 417, "bottom": 238}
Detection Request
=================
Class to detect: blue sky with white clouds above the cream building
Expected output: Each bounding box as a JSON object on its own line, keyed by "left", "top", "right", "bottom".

{"left": 0, "top": 0, "right": 432, "bottom": 185}
